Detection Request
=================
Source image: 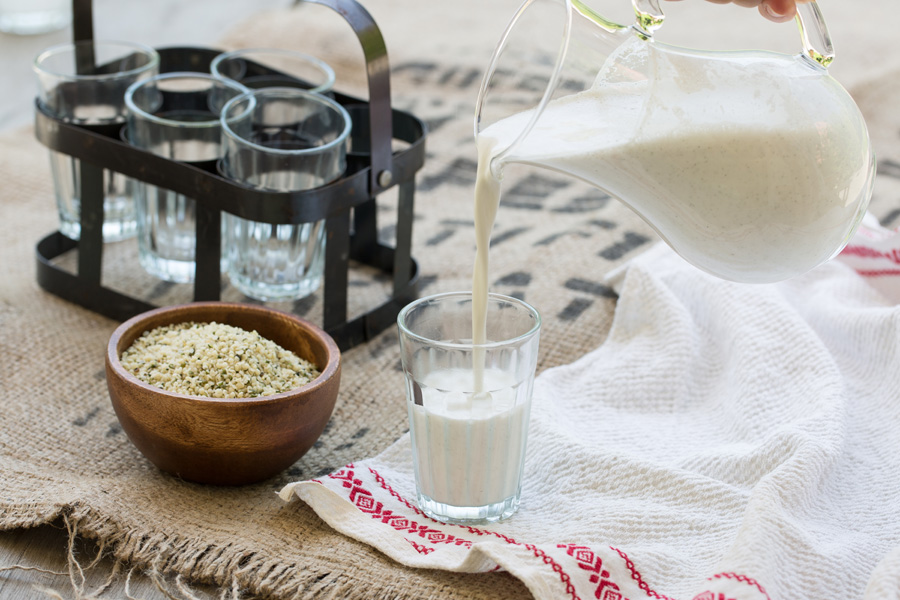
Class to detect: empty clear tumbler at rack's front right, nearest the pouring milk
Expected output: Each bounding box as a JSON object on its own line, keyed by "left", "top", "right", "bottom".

{"left": 221, "top": 88, "right": 351, "bottom": 301}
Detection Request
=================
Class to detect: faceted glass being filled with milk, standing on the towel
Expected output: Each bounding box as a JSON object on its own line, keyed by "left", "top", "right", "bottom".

{"left": 397, "top": 292, "right": 541, "bottom": 524}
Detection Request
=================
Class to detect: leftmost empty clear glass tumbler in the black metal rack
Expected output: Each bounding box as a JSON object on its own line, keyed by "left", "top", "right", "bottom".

{"left": 34, "top": 41, "right": 159, "bottom": 242}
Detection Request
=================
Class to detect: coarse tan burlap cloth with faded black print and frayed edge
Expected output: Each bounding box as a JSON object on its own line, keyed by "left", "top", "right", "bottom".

{"left": 0, "top": 0, "right": 900, "bottom": 598}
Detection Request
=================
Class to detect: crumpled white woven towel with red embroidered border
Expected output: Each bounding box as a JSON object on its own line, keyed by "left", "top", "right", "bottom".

{"left": 282, "top": 217, "right": 900, "bottom": 600}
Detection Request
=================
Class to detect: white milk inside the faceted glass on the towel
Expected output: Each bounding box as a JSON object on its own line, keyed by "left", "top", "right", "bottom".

{"left": 409, "top": 369, "right": 530, "bottom": 507}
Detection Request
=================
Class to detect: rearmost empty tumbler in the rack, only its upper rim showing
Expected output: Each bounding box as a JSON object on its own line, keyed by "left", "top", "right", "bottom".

{"left": 210, "top": 48, "right": 334, "bottom": 94}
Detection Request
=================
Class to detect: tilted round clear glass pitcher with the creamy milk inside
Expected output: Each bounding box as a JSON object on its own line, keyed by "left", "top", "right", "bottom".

{"left": 475, "top": 0, "right": 875, "bottom": 283}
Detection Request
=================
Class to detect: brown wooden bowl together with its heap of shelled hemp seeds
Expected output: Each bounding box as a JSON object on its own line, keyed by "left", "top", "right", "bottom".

{"left": 106, "top": 302, "right": 341, "bottom": 485}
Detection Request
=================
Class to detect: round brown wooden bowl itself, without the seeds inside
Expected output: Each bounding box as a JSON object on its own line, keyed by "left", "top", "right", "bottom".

{"left": 106, "top": 302, "right": 341, "bottom": 485}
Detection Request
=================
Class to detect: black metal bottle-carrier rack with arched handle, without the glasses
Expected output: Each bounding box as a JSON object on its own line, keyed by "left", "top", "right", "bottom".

{"left": 35, "top": 0, "right": 426, "bottom": 349}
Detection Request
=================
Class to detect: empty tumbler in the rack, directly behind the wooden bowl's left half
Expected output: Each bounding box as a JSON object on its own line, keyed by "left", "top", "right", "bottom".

{"left": 125, "top": 72, "right": 247, "bottom": 283}
